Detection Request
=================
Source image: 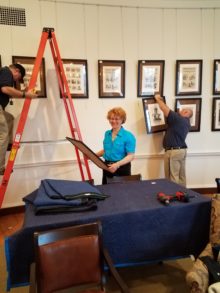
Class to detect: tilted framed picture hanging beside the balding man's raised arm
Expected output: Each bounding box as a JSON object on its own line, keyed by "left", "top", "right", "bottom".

{"left": 142, "top": 97, "right": 167, "bottom": 133}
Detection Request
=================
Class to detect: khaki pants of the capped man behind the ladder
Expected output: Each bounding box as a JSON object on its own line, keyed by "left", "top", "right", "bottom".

{"left": 0, "top": 105, "right": 14, "bottom": 175}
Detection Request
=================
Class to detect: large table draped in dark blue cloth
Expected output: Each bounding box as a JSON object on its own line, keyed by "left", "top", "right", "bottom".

{"left": 5, "top": 179, "right": 211, "bottom": 289}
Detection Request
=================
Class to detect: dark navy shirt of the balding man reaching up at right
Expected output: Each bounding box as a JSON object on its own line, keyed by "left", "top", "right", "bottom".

{"left": 163, "top": 110, "right": 191, "bottom": 148}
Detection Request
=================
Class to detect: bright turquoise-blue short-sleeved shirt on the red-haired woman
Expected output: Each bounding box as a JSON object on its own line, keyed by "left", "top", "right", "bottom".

{"left": 103, "top": 127, "right": 136, "bottom": 162}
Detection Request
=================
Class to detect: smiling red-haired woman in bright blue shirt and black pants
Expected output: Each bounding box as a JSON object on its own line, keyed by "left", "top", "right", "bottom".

{"left": 97, "top": 107, "right": 136, "bottom": 184}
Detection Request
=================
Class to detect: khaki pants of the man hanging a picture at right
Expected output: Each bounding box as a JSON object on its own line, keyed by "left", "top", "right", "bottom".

{"left": 164, "top": 149, "right": 186, "bottom": 187}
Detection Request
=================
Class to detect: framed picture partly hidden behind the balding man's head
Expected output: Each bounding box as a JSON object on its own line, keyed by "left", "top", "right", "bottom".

{"left": 175, "top": 98, "right": 202, "bottom": 132}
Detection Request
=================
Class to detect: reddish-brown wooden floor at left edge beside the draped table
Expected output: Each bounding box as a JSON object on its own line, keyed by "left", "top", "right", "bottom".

{"left": 0, "top": 212, "right": 24, "bottom": 245}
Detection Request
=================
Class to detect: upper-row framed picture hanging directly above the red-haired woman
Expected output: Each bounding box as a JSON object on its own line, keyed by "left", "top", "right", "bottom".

{"left": 98, "top": 60, "right": 125, "bottom": 98}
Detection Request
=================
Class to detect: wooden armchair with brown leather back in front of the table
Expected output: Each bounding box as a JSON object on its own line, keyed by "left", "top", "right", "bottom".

{"left": 29, "top": 222, "right": 129, "bottom": 293}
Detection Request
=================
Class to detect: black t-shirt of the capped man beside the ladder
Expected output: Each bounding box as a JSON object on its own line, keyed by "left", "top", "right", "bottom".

{"left": 0, "top": 66, "right": 14, "bottom": 109}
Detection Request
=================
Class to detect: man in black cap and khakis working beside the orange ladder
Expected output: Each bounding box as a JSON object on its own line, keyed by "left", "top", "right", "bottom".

{"left": 0, "top": 63, "right": 37, "bottom": 175}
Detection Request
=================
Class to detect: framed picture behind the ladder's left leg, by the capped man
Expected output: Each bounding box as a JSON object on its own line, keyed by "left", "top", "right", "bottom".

{"left": 12, "top": 56, "right": 46, "bottom": 98}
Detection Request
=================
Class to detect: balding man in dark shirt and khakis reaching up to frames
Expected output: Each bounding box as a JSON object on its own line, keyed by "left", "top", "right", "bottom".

{"left": 154, "top": 94, "right": 193, "bottom": 187}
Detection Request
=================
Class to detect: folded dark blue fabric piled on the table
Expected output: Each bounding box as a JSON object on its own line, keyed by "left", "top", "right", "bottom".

{"left": 33, "top": 179, "right": 106, "bottom": 207}
